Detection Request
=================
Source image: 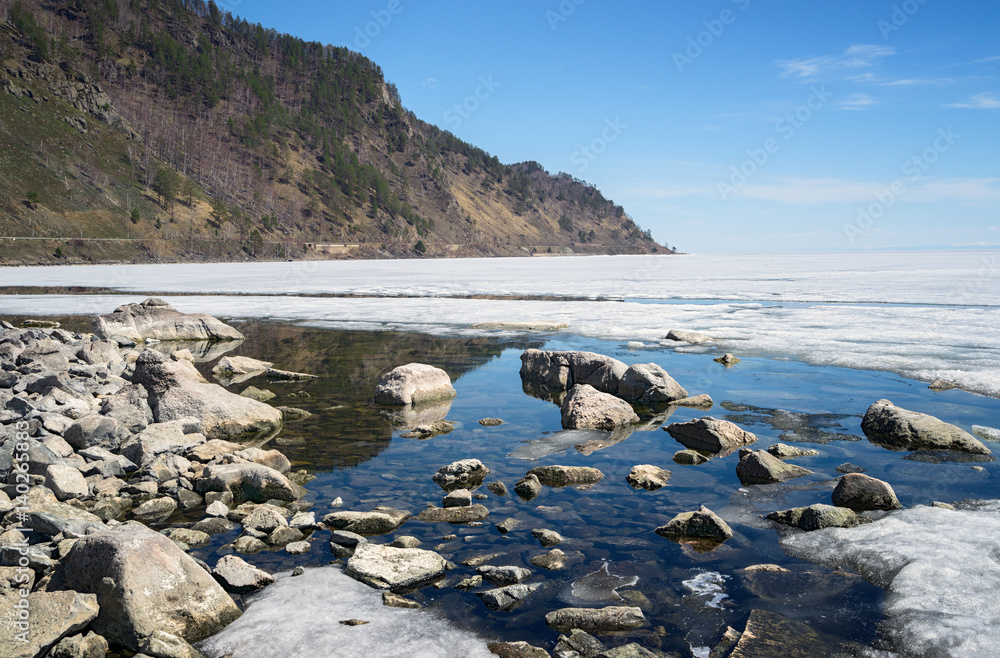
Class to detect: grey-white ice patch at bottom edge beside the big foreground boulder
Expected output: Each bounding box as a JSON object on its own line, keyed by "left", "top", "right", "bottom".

{"left": 199, "top": 567, "right": 492, "bottom": 658}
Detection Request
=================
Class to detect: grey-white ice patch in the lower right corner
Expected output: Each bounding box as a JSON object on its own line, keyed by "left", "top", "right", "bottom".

{"left": 781, "top": 501, "right": 1000, "bottom": 658}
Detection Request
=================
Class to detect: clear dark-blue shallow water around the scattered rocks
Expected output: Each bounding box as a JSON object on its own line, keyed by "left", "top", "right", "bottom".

{"left": 154, "top": 322, "right": 1000, "bottom": 655}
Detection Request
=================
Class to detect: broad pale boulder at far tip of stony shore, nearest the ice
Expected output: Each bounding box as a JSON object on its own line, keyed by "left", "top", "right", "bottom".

{"left": 93, "top": 297, "right": 243, "bottom": 343}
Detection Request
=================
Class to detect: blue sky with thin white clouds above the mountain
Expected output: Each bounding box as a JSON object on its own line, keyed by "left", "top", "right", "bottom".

{"left": 227, "top": 0, "right": 1000, "bottom": 253}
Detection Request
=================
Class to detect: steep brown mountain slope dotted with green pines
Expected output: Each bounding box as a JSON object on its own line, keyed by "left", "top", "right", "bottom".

{"left": 0, "top": 0, "right": 665, "bottom": 262}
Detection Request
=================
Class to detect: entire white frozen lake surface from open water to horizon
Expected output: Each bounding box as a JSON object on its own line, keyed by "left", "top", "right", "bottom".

{"left": 0, "top": 252, "right": 1000, "bottom": 397}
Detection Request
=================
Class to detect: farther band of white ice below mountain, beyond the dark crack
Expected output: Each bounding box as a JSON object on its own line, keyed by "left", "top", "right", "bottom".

{"left": 0, "top": 251, "right": 1000, "bottom": 305}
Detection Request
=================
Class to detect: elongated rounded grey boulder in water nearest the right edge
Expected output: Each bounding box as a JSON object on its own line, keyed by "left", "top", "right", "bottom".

{"left": 861, "top": 400, "right": 990, "bottom": 455}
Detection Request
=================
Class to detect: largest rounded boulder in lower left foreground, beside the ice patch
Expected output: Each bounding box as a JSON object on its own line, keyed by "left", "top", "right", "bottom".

{"left": 59, "top": 523, "right": 240, "bottom": 651}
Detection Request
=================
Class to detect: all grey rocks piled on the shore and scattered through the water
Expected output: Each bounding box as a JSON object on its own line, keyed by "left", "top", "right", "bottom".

{"left": 0, "top": 299, "right": 990, "bottom": 658}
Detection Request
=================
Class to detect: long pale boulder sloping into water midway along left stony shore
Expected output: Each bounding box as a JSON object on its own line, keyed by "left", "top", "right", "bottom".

{"left": 132, "top": 350, "right": 281, "bottom": 440}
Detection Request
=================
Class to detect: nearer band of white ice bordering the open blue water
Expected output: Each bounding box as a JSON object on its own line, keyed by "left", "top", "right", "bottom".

{"left": 0, "top": 295, "right": 1000, "bottom": 397}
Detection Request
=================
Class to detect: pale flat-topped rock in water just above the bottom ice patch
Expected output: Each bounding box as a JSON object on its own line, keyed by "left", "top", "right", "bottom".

{"left": 345, "top": 543, "right": 446, "bottom": 591}
